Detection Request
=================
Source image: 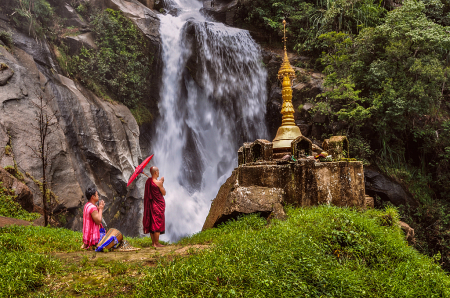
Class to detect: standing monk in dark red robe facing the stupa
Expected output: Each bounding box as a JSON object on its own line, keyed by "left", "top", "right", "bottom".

{"left": 142, "top": 167, "right": 166, "bottom": 247}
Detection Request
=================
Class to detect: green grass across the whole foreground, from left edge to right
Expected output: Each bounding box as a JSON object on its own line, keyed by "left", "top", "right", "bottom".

{"left": 0, "top": 206, "right": 450, "bottom": 297}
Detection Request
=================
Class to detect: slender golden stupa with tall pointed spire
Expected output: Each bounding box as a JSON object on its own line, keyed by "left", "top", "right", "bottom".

{"left": 273, "top": 20, "right": 302, "bottom": 152}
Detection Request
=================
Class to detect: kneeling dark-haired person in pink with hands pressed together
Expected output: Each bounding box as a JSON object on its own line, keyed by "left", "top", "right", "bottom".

{"left": 81, "top": 186, "right": 105, "bottom": 249}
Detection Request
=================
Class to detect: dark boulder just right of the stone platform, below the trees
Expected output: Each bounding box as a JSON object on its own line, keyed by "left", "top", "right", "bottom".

{"left": 364, "top": 168, "right": 418, "bottom": 207}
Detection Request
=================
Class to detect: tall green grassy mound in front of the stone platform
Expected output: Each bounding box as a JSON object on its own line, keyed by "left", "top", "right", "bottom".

{"left": 137, "top": 206, "right": 450, "bottom": 297}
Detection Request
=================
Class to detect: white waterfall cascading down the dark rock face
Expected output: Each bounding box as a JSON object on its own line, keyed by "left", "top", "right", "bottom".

{"left": 152, "top": 0, "right": 267, "bottom": 241}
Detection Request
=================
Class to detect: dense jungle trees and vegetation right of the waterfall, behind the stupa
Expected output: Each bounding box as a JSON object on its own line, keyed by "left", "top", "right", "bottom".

{"left": 239, "top": 0, "right": 450, "bottom": 270}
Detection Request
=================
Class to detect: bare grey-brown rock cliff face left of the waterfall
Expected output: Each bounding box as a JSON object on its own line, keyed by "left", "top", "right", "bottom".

{"left": 0, "top": 0, "right": 159, "bottom": 235}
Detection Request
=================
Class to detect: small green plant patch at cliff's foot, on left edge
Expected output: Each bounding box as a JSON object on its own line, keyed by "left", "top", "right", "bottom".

{"left": 0, "top": 181, "right": 41, "bottom": 221}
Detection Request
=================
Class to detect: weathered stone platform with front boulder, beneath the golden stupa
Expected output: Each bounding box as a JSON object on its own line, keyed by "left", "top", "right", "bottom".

{"left": 202, "top": 159, "right": 365, "bottom": 230}
